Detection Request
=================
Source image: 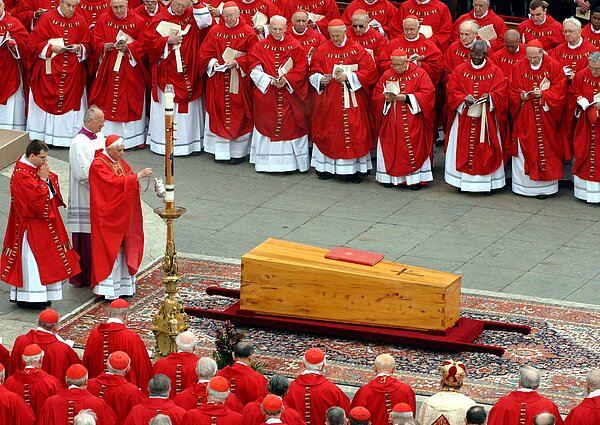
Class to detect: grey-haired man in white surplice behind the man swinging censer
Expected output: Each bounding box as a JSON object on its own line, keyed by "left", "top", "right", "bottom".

{"left": 67, "top": 105, "right": 104, "bottom": 286}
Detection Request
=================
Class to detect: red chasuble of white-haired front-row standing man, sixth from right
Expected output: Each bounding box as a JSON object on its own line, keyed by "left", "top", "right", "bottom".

{"left": 249, "top": 35, "right": 309, "bottom": 142}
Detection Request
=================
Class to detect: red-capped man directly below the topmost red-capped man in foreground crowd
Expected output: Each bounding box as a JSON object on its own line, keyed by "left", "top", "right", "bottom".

{"left": 87, "top": 351, "right": 146, "bottom": 423}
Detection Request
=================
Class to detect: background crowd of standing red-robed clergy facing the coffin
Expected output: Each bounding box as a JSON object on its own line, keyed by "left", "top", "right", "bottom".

{"left": 0, "top": 0, "right": 600, "bottom": 203}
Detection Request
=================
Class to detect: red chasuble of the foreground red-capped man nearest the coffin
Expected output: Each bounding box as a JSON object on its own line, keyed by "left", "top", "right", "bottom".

{"left": 284, "top": 373, "right": 350, "bottom": 424}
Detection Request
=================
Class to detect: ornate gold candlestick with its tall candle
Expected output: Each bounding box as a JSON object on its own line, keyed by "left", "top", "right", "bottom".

{"left": 152, "top": 84, "right": 188, "bottom": 361}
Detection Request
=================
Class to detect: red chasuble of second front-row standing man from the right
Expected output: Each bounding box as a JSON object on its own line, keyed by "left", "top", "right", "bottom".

{"left": 510, "top": 56, "right": 570, "bottom": 181}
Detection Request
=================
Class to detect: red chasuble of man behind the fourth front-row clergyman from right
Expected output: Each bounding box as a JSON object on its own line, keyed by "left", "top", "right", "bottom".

{"left": 386, "top": 34, "right": 443, "bottom": 86}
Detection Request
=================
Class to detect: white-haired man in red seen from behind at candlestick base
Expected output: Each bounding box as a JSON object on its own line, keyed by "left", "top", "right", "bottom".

{"left": 152, "top": 331, "right": 198, "bottom": 398}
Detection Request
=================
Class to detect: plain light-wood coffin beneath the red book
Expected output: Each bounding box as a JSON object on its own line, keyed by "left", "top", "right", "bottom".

{"left": 240, "top": 239, "right": 461, "bottom": 332}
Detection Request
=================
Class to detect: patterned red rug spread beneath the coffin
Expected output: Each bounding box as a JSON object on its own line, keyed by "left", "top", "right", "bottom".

{"left": 60, "top": 253, "right": 600, "bottom": 413}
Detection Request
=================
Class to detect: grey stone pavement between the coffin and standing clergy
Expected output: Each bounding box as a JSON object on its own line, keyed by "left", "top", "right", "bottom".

{"left": 0, "top": 148, "right": 600, "bottom": 347}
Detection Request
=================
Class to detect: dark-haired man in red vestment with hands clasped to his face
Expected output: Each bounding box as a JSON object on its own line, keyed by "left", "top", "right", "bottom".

{"left": 0, "top": 140, "right": 81, "bottom": 305}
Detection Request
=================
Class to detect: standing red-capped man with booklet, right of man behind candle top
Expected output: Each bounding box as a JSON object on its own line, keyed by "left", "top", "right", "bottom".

{"left": 200, "top": 1, "right": 258, "bottom": 165}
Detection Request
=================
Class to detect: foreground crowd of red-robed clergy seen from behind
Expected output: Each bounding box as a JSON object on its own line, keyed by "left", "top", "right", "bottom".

{"left": 0, "top": 308, "right": 600, "bottom": 425}
